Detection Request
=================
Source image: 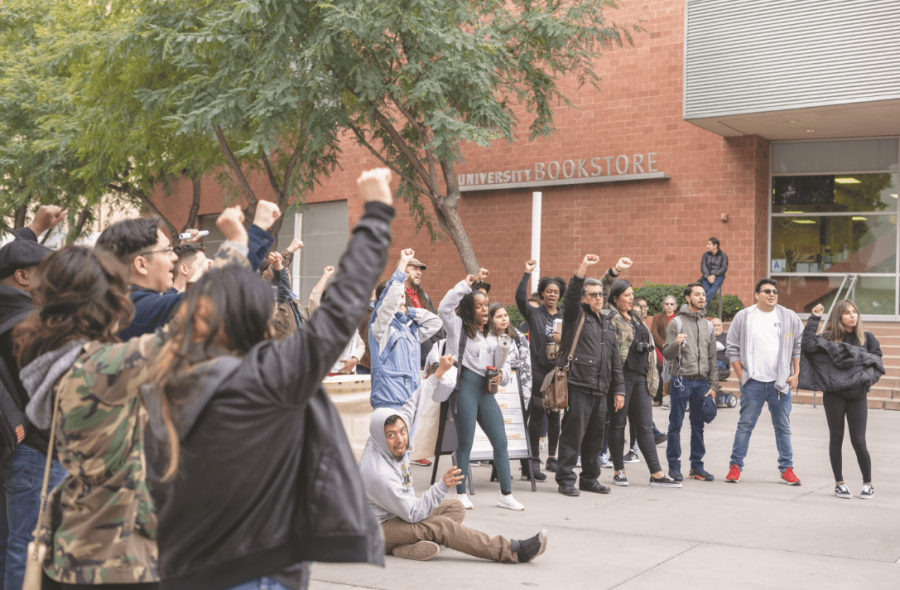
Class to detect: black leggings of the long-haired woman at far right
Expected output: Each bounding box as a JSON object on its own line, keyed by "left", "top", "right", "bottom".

{"left": 823, "top": 391, "right": 872, "bottom": 483}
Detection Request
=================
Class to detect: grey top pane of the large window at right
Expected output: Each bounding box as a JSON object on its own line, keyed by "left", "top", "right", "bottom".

{"left": 772, "top": 138, "right": 897, "bottom": 174}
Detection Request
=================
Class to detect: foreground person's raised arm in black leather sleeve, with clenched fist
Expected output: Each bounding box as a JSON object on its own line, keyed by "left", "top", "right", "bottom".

{"left": 259, "top": 168, "right": 395, "bottom": 404}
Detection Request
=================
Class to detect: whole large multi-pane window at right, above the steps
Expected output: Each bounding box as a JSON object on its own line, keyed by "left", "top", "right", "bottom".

{"left": 769, "top": 138, "right": 900, "bottom": 320}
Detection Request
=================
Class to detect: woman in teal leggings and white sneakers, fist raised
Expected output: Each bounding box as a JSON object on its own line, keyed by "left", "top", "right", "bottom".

{"left": 438, "top": 268, "right": 525, "bottom": 510}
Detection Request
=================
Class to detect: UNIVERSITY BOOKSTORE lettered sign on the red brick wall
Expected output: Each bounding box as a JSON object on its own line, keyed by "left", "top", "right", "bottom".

{"left": 457, "top": 152, "right": 669, "bottom": 192}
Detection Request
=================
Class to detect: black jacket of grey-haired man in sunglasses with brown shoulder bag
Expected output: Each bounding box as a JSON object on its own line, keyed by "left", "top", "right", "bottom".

{"left": 559, "top": 275, "right": 625, "bottom": 395}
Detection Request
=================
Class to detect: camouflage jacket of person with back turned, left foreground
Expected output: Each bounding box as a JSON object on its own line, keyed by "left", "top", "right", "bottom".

{"left": 39, "top": 242, "right": 249, "bottom": 585}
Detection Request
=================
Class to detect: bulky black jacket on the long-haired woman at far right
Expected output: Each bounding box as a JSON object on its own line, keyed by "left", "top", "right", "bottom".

{"left": 798, "top": 315, "right": 884, "bottom": 399}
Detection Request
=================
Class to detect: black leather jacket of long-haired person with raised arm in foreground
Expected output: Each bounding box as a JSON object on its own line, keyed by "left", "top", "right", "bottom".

{"left": 141, "top": 203, "right": 394, "bottom": 590}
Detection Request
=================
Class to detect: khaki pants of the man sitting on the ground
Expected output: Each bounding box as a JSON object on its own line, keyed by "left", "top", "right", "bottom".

{"left": 381, "top": 500, "right": 519, "bottom": 563}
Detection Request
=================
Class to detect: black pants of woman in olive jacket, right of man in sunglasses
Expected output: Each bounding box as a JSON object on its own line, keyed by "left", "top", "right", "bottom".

{"left": 612, "top": 371, "right": 662, "bottom": 473}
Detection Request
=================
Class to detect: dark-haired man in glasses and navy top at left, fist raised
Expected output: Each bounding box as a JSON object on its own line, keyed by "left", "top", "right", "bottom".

{"left": 96, "top": 201, "right": 280, "bottom": 340}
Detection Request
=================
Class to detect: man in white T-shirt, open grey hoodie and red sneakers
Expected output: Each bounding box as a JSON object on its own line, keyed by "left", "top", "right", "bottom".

{"left": 725, "top": 279, "right": 803, "bottom": 486}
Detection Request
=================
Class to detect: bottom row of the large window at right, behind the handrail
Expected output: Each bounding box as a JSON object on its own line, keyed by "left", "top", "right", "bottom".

{"left": 777, "top": 277, "right": 896, "bottom": 315}
